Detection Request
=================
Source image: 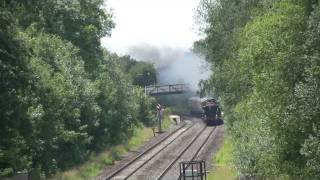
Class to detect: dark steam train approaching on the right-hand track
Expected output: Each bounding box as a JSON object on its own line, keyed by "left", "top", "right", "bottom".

{"left": 189, "top": 97, "right": 223, "bottom": 126}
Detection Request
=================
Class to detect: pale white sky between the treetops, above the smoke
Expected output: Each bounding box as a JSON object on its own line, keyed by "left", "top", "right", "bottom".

{"left": 102, "top": 0, "right": 199, "bottom": 54}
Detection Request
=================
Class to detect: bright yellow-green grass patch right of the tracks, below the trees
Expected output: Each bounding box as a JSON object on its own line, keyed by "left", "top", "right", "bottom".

{"left": 208, "top": 137, "right": 237, "bottom": 180}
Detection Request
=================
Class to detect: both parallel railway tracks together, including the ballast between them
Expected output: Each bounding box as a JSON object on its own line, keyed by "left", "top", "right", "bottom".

{"left": 103, "top": 119, "right": 215, "bottom": 180}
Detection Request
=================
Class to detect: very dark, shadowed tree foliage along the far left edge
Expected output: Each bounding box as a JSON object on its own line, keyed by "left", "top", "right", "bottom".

{"left": 0, "top": 6, "right": 31, "bottom": 175}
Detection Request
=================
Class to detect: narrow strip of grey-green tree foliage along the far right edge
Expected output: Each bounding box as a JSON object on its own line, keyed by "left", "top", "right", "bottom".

{"left": 295, "top": 3, "right": 320, "bottom": 179}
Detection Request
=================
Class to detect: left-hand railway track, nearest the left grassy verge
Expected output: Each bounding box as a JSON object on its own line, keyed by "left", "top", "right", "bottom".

{"left": 104, "top": 120, "right": 195, "bottom": 180}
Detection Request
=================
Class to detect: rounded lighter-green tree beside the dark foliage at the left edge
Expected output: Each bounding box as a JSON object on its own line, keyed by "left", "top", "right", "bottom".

{"left": 22, "top": 32, "right": 92, "bottom": 174}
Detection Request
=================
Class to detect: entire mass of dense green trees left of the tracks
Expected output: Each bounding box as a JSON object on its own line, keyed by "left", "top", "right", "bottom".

{"left": 0, "top": 0, "right": 155, "bottom": 178}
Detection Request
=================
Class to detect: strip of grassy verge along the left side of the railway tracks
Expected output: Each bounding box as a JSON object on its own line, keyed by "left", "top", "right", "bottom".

{"left": 53, "top": 128, "right": 153, "bottom": 180}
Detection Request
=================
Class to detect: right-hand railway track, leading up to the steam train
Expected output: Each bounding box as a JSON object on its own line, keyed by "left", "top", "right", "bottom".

{"left": 157, "top": 127, "right": 215, "bottom": 180}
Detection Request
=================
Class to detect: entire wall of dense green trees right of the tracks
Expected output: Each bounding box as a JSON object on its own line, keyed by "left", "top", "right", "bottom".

{"left": 194, "top": 0, "right": 320, "bottom": 179}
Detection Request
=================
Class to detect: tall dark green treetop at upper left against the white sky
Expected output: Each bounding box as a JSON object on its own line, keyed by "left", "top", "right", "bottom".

{"left": 11, "top": 0, "right": 114, "bottom": 72}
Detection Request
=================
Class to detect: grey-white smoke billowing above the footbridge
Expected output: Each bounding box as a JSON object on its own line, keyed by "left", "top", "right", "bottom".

{"left": 129, "top": 44, "right": 210, "bottom": 92}
